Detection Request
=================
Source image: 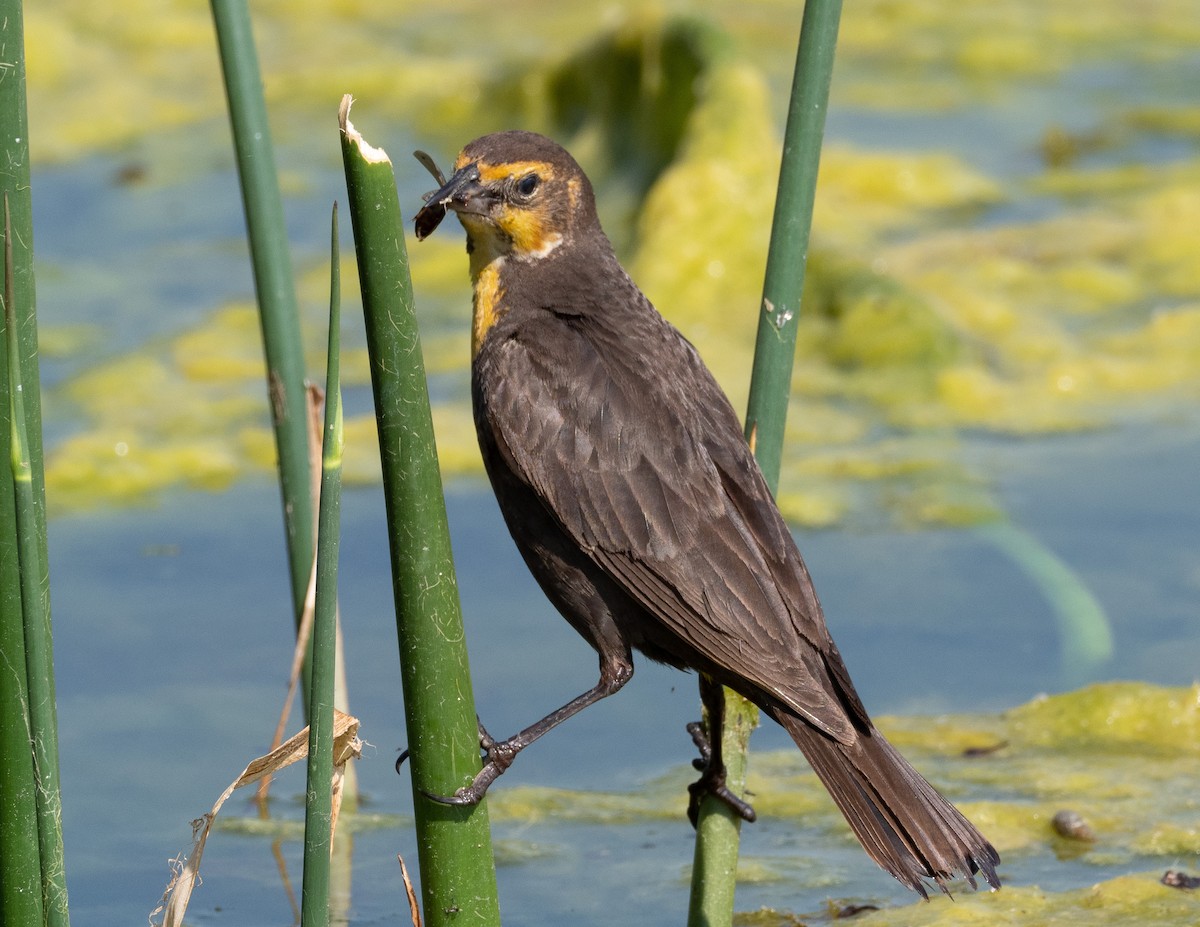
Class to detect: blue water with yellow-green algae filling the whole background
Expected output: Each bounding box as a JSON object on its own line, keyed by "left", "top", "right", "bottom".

{"left": 26, "top": 0, "right": 1200, "bottom": 925}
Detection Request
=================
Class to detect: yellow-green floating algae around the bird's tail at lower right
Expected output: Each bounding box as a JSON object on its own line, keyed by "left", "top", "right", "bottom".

{"left": 490, "top": 683, "right": 1200, "bottom": 927}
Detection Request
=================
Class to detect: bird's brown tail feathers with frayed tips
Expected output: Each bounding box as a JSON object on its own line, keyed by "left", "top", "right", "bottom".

{"left": 778, "top": 712, "right": 1000, "bottom": 897}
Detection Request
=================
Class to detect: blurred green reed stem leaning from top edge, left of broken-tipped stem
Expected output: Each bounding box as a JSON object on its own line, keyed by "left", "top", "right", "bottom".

{"left": 211, "top": 0, "right": 313, "bottom": 714}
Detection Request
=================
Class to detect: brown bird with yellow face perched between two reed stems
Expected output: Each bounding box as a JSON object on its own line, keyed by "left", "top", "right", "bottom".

{"left": 415, "top": 132, "right": 1000, "bottom": 895}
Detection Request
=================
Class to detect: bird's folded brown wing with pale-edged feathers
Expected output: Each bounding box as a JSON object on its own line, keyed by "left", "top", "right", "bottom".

{"left": 476, "top": 310, "right": 869, "bottom": 742}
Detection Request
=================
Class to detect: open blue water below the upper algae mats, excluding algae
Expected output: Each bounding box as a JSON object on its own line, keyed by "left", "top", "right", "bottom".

{"left": 50, "top": 423, "right": 1200, "bottom": 925}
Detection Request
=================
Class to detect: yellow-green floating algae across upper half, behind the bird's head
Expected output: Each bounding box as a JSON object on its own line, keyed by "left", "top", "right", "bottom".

{"left": 29, "top": 0, "right": 1200, "bottom": 540}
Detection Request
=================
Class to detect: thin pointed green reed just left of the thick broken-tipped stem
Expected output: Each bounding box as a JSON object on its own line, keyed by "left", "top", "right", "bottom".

{"left": 300, "top": 204, "right": 346, "bottom": 927}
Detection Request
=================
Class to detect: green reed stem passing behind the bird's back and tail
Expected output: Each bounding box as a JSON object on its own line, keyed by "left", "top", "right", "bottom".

{"left": 688, "top": 0, "right": 841, "bottom": 927}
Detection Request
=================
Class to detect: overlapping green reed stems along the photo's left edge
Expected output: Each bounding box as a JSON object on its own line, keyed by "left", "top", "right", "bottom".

{"left": 0, "top": 0, "right": 66, "bottom": 925}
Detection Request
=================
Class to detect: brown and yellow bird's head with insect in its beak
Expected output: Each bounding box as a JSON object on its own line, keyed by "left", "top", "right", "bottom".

{"left": 415, "top": 131, "right": 599, "bottom": 263}
